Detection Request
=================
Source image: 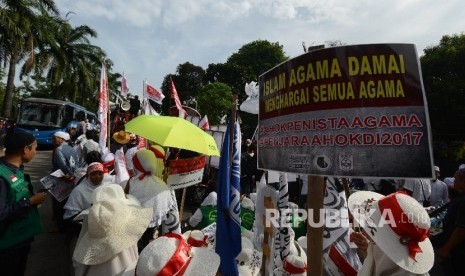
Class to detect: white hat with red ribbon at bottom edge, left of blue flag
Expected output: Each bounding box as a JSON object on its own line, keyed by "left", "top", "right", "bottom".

{"left": 136, "top": 233, "right": 220, "bottom": 276}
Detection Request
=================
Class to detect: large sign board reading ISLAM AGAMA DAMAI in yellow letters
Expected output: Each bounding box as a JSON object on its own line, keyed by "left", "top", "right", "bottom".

{"left": 257, "top": 44, "right": 433, "bottom": 178}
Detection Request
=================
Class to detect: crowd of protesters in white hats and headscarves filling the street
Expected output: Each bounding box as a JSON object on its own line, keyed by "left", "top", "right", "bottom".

{"left": 0, "top": 124, "right": 465, "bottom": 275}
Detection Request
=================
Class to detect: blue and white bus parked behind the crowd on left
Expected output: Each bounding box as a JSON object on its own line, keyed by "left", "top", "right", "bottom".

{"left": 14, "top": 98, "right": 97, "bottom": 146}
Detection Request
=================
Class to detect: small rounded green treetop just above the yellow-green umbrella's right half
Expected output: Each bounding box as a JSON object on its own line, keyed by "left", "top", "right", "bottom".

{"left": 196, "top": 82, "right": 233, "bottom": 125}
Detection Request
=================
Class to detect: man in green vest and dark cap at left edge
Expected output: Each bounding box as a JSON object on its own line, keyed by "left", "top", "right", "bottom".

{"left": 0, "top": 133, "right": 47, "bottom": 276}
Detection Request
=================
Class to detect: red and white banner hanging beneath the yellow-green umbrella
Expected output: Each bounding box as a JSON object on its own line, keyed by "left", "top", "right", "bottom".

{"left": 167, "top": 155, "right": 205, "bottom": 190}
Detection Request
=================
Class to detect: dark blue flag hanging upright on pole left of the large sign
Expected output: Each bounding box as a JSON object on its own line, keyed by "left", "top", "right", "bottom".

{"left": 215, "top": 115, "right": 242, "bottom": 275}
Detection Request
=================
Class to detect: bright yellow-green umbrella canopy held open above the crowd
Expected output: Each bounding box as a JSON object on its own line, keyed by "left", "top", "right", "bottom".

{"left": 125, "top": 115, "right": 220, "bottom": 156}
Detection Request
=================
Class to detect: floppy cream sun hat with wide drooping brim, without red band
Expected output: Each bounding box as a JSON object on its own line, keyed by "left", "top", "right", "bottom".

{"left": 73, "top": 184, "right": 152, "bottom": 265}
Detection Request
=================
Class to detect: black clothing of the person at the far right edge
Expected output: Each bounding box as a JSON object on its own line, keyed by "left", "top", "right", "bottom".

{"left": 435, "top": 193, "right": 465, "bottom": 275}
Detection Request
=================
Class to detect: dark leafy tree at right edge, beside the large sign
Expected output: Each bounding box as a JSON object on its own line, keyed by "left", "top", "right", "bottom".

{"left": 420, "top": 33, "right": 465, "bottom": 166}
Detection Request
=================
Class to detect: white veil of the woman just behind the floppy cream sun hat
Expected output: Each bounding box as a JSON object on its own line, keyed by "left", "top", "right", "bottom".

{"left": 63, "top": 177, "right": 104, "bottom": 219}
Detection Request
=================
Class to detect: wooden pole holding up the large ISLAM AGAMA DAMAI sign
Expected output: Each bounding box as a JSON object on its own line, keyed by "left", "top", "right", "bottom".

{"left": 307, "top": 176, "right": 325, "bottom": 276}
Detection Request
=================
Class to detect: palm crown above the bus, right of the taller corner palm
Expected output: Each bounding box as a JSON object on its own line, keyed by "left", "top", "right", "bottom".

{"left": 27, "top": 15, "right": 106, "bottom": 104}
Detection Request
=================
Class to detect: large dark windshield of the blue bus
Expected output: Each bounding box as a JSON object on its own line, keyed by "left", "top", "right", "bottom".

{"left": 18, "top": 102, "right": 62, "bottom": 127}
